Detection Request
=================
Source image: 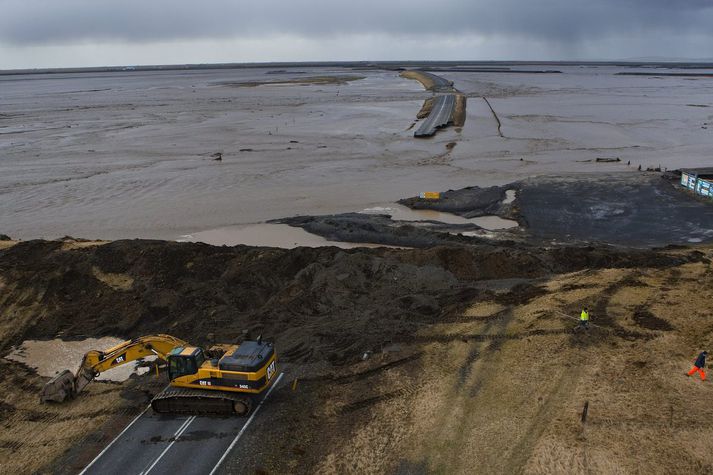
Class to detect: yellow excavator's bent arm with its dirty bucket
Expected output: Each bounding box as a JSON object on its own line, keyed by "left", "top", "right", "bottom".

{"left": 40, "top": 334, "right": 188, "bottom": 402}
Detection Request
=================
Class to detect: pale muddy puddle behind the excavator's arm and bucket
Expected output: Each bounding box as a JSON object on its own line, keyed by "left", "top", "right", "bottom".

{"left": 5, "top": 337, "right": 156, "bottom": 381}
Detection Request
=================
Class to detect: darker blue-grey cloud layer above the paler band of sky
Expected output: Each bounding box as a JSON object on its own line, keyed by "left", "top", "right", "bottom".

{"left": 0, "top": 0, "right": 713, "bottom": 47}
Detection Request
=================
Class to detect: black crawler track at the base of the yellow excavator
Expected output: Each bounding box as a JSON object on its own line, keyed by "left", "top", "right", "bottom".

{"left": 151, "top": 387, "right": 252, "bottom": 416}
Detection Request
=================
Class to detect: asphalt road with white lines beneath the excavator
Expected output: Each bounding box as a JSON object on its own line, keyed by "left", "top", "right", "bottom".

{"left": 81, "top": 374, "right": 283, "bottom": 475}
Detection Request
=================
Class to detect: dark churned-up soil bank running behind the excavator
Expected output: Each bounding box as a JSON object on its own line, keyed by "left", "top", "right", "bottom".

{"left": 0, "top": 240, "right": 701, "bottom": 359}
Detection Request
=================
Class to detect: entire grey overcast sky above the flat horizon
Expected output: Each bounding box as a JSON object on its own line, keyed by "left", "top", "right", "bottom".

{"left": 0, "top": 0, "right": 713, "bottom": 69}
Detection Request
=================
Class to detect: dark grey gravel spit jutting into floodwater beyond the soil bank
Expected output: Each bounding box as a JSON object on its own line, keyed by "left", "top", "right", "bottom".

{"left": 270, "top": 172, "right": 713, "bottom": 247}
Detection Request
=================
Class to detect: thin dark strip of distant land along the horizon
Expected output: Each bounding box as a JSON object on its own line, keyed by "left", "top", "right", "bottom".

{"left": 0, "top": 61, "right": 713, "bottom": 76}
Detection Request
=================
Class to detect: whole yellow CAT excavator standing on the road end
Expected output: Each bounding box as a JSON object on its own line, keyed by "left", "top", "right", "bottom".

{"left": 40, "top": 335, "right": 277, "bottom": 416}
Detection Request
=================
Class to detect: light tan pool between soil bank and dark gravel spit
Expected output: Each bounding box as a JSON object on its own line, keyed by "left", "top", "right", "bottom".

{"left": 177, "top": 223, "right": 404, "bottom": 249}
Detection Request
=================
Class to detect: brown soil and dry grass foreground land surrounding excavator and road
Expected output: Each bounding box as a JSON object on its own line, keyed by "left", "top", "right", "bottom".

{"left": 0, "top": 240, "right": 713, "bottom": 473}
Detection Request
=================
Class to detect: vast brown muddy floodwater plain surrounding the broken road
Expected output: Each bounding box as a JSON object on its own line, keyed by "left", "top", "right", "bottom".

{"left": 0, "top": 66, "right": 713, "bottom": 239}
